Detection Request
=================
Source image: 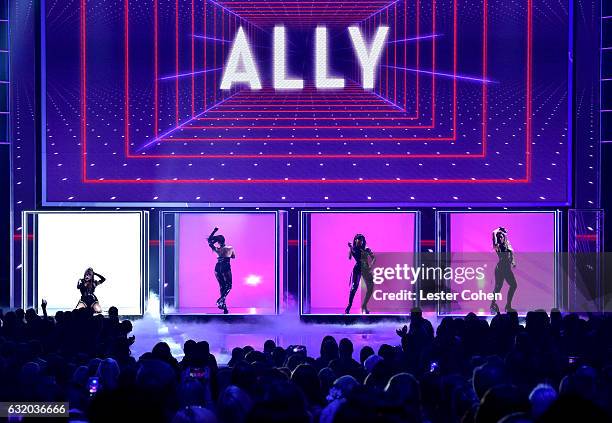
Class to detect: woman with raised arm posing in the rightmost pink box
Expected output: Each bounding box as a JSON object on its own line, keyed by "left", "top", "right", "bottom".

{"left": 491, "top": 227, "right": 516, "bottom": 314}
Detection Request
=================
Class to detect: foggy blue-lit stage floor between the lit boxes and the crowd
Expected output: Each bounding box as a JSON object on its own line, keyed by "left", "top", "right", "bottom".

{"left": 131, "top": 296, "right": 478, "bottom": 365}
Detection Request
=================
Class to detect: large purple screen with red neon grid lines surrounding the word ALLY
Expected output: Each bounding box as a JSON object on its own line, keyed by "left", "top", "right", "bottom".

{"left": 45, "top": 0, "right": 570, "bottom": 204}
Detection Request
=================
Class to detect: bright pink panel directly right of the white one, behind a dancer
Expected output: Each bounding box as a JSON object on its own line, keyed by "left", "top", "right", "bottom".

{"left": 177, "top": 213, "right": 277, "bottom": 314}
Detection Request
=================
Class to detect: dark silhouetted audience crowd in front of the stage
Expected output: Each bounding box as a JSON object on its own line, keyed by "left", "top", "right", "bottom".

{"left": 0, "top": 307, "right": 612, "bottom": 423}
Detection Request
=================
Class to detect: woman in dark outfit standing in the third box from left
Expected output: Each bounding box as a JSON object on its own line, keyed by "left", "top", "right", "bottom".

{"left": 345, "top": 234, "right": 376, "bottom": 314}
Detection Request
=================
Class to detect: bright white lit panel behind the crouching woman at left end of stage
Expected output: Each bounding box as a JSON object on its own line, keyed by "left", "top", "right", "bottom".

{"left": 36, "top": 213, "right": 143, "bottom": 315}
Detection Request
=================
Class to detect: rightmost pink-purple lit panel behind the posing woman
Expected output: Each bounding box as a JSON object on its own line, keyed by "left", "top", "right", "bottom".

{"left": 448, "top": 212, "right": 555, "bottom": 314}
